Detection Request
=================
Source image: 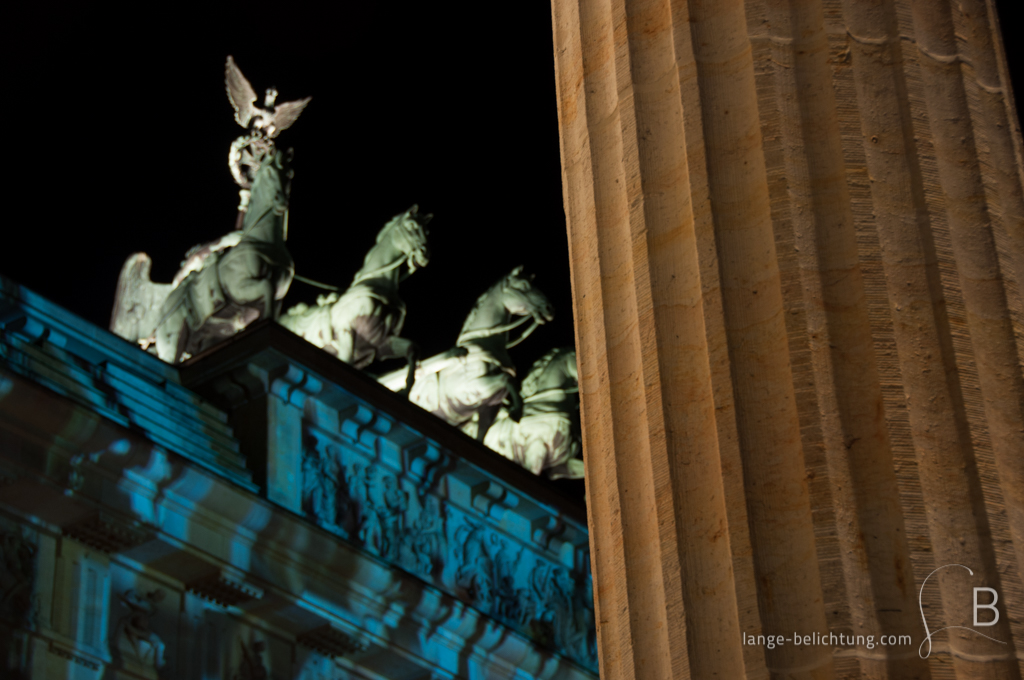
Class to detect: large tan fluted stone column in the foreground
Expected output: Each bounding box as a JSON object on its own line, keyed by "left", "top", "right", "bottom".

{"left": 552, "top": 0, "right": 1024, "bottom": 680}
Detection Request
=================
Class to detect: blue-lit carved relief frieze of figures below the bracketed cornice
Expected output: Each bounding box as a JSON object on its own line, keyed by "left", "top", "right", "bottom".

{"left": 303, "top": 427, "right": 596, "bottom": 668}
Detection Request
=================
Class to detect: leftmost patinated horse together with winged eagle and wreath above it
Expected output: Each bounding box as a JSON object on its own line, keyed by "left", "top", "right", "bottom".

{"left": 111, "top": 56, "right": 310, "bottom": 364}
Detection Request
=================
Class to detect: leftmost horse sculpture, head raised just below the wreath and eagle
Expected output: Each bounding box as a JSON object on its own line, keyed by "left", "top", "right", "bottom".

{"left": 111, "top": 146, "right": 295, "bottom": 364}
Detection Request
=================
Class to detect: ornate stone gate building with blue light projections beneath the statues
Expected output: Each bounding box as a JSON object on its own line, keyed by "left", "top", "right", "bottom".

{"left": 0, "top": 279, "right": 597, "bottom": 680}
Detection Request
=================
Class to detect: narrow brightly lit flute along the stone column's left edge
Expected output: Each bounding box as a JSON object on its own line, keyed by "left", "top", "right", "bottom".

{"left": 552, "top": 1, "right": 635, "bottom": 679}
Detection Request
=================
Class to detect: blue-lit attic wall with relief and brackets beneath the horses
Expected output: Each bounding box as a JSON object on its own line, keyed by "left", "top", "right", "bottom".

{"left": 302, "top": 407, "right": 596, "bottom": 668}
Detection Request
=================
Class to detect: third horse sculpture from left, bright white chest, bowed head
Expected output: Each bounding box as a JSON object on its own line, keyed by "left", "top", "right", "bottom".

{"left": 379, "top": 266, "right": 554, "bottom": 441}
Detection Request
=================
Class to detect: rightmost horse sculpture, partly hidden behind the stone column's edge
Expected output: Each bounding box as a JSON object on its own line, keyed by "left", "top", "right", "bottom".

{"left": 483, "top": 347, "right": 584, "bottom": 479}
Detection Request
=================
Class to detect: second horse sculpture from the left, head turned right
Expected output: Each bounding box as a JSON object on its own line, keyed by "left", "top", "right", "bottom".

{"left": 278, "top": 206, "right": 432, "bottom": 394}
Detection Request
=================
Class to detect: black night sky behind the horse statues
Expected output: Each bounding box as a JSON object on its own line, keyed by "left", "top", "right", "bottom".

{"left": 6, "top": 1, "right": 1024, "bottom": 503}
